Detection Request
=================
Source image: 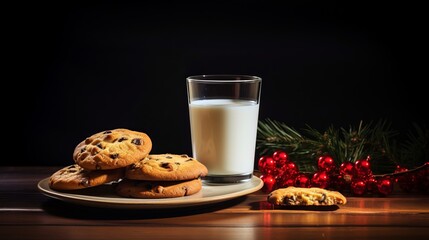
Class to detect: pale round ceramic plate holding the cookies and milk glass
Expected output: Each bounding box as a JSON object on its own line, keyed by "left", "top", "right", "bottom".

{"left": 37, "top": 176, "right": 263, "bottom": 209}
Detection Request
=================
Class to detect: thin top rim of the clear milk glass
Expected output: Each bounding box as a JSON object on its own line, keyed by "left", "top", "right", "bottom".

{"left": 186, "top": 74, "right": 262, "bottom": 82}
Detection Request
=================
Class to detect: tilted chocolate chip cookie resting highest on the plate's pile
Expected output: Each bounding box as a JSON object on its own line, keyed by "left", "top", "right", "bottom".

{"left": 73, "top": 128, "right": 152, "bottom": 170}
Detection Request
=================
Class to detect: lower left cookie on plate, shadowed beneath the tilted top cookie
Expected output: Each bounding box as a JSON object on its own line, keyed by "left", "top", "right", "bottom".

{"left": 49, "top": 164, "right": 124, "bottom": 190}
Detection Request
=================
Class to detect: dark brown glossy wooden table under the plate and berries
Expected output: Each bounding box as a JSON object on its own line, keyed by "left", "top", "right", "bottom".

{"left": 0, "top": 167, "right": 429, "bottom": 240}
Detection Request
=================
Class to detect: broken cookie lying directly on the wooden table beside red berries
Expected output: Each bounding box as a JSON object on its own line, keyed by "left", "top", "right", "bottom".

{"left": 267, "top": 187, "right": 347, "bottom": 206}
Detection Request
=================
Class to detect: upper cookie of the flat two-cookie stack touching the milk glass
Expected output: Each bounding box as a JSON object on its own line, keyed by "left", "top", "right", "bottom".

{"left": 125, "top": 153, "right": 208, "bottom": 181}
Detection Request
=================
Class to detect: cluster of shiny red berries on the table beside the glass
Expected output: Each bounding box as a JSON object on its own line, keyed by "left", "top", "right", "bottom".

{"left": 258, "top": 150, "right": 429, "bottom": 196}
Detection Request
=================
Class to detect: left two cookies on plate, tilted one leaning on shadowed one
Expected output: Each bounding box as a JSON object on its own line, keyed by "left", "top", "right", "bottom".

{"left": 50, "top": 128, "right": 152, "bottom": 190}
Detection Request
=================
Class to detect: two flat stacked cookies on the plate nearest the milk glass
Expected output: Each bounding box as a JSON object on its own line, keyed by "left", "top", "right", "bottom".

{"left": 116, "top": 154, "right": 207, "bottom": 198}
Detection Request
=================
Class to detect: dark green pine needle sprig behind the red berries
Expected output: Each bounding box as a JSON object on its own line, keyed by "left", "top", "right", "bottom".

{"left": 256, "top": 119, "right": 429, "bottom": 174}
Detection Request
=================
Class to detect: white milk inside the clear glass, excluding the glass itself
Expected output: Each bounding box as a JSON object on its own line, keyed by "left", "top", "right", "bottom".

{"left": 189, "top": 99, "right": 259, "bottom": 176}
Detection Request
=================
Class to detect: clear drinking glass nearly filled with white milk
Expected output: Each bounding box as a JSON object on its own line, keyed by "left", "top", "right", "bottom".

{"left": 186, "top": 75, "right": 262, "bottom": 183}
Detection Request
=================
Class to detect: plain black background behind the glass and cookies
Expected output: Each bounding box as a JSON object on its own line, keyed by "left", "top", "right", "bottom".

{"left": 9, "top": 1, "right": 428, "bottom": 165}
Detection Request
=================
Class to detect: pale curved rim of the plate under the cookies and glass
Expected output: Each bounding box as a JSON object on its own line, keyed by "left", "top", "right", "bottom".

{"left": 37, "top": 175, "right": 263, "bottom": 208}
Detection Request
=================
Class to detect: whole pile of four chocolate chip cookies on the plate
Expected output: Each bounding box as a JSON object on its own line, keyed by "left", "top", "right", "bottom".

{"left": 50, "top": 128, "right": 208, "bottom": 198}
